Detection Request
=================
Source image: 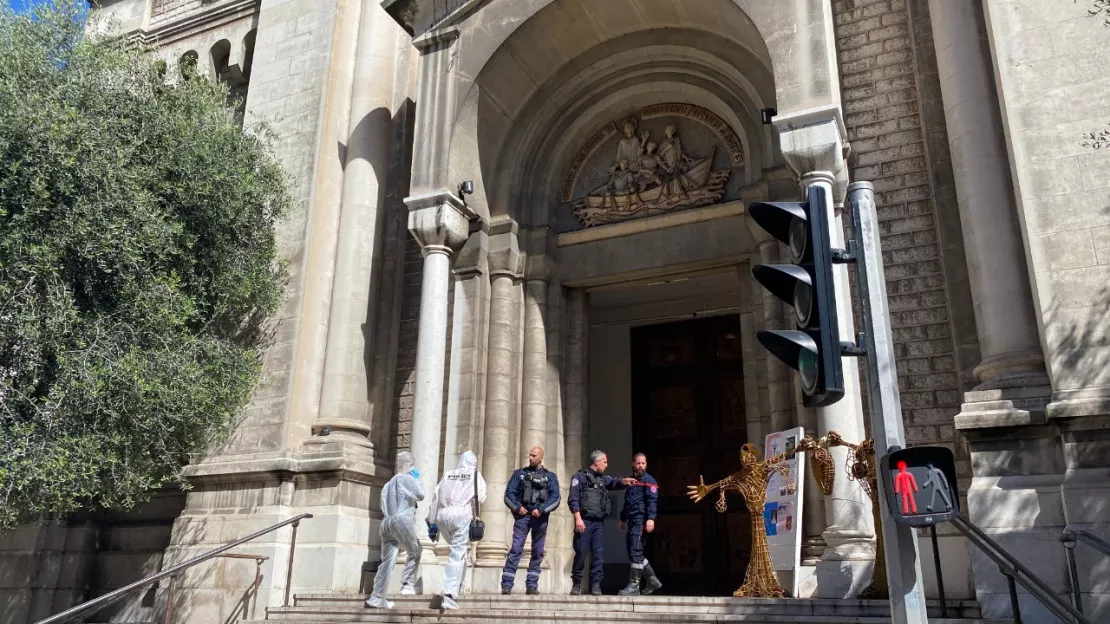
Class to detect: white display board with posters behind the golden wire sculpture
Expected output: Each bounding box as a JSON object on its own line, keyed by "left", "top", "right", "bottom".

{"left": 764, "top": 426, "right": 806, "bottom": 596}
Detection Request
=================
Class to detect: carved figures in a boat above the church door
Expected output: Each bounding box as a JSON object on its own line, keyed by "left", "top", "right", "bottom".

{"left": 564, "top": 105, "right": 738, "bottom": 227}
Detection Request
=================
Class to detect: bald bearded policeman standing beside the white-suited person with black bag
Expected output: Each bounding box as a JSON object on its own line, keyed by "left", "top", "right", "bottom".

{"left": 501, "top": 446, "right": 559, "bottom": 594}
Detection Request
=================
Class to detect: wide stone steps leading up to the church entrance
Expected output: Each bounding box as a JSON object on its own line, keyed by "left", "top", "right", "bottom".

{"left": 244, "top": 594, "right": 1012, "bottom": 624}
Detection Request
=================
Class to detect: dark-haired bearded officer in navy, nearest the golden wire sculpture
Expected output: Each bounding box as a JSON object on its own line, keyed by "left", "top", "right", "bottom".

{"left": 617, "top": 453, "right": 663, "bottom": 596}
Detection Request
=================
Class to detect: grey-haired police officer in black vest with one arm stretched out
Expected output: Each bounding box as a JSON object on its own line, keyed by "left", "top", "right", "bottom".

{"left": 566, "top": 451, "right": 635, "bottom": 596}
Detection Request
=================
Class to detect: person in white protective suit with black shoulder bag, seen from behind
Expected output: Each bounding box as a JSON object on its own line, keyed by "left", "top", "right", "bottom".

{"left": 428, "top": 451, "right": 485, "bottom": 597}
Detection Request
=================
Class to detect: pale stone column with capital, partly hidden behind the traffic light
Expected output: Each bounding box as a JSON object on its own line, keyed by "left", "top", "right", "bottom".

{"left": 775, "top": 107, "right": 875, "bottom": 598}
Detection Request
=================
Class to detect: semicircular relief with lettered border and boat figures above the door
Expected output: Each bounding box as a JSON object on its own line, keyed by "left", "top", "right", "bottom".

{"left": 562, "top": 104, "right": 744, "bottom": 228}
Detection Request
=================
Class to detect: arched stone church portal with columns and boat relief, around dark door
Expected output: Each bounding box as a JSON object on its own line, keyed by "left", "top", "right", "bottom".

{"left": 397, "top": 0, "right": 865, "bottom": 592}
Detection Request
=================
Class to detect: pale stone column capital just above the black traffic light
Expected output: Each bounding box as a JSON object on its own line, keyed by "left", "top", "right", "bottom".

{"left": 775, "top": 105, "right": 848, "bottom": 201}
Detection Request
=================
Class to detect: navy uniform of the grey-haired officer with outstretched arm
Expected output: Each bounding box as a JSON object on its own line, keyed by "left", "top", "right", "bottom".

{"left": 566, "top": 467, "right": 624, "bottom": 585}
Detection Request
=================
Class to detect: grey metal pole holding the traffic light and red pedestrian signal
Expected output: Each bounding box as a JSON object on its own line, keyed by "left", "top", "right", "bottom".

{"left": 848, "top": 182, "right": 929, "bottom": 624}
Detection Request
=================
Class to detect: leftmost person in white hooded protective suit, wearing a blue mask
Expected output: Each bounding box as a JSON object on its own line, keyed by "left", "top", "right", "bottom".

{"left": 372, "top": 451, "right": 424, "bottom": 598}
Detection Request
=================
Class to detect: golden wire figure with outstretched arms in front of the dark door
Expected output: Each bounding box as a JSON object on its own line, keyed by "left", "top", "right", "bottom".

{"left": 686, "top": 435, "right": 834, "bottom": 598}
